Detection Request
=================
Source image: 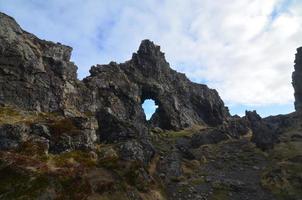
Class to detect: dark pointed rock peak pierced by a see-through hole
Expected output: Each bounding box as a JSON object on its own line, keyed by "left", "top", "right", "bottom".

{"left": 84, "top": 40, "right": 229, "bottom": 134}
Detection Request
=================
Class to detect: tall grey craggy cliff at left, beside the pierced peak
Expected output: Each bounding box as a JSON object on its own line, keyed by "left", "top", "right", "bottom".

{"left": 0, "top": 13, "right": 89, "bottom": 115}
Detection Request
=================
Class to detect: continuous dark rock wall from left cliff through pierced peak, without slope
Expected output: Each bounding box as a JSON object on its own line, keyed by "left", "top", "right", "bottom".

{"left": 0, "top": 13, "right": 229, "bottom": 136}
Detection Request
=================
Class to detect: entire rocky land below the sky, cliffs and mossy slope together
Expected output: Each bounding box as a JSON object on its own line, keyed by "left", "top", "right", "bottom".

{"left": 0, "top": 13, "right": 302, "bottom": 200}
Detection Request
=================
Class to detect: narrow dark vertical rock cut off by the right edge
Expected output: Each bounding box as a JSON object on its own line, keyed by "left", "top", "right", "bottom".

{"left": 292, "top": 47, "right": 302, "bottom": 113}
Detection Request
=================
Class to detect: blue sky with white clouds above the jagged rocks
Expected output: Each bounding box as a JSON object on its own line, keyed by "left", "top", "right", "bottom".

{"left": 0, "top": 0, "right": 302, "bottom": 116}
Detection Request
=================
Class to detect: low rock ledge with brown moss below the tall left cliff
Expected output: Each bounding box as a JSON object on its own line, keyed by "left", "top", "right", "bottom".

{"left": 0, "top": 117, "right": 98, "bottom": 153}
